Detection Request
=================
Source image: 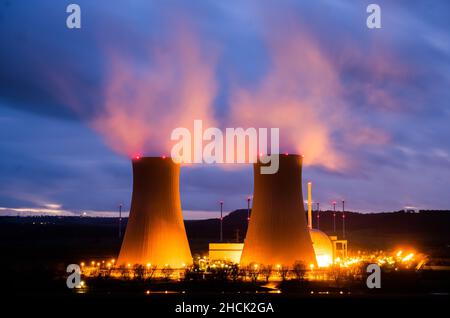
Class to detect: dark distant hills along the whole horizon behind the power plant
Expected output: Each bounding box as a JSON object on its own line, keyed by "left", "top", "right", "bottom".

{"left": 0, "top": 209, "right": 450, "bottom": 260}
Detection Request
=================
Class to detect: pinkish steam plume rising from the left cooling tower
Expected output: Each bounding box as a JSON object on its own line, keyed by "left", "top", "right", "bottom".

{"left": 92, "top": 26, "right": 217, "bottom": 156}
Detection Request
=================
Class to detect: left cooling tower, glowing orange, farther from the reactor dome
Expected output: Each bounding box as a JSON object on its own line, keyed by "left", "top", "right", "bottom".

{"left": 118, "top": 157, "right": 192, "bottom": 268}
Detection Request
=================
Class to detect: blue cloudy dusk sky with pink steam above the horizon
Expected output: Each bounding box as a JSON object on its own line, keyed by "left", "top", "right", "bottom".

{"left": 0, "top": 0, "right": 450, "bottom": 218}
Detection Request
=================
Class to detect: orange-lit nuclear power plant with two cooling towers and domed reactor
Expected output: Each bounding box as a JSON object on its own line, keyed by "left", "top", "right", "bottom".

{"left": 117, "top": 154, "right": 346, "bottom": 268}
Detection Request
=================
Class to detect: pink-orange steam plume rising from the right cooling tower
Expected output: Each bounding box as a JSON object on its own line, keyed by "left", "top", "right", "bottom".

{"left": 230, "top": 25, "right": 387, "bottom": 171}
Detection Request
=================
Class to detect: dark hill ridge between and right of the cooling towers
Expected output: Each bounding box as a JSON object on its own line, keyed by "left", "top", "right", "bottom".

{"left": 185, "top": 209, "right": 450, "bottom": 254}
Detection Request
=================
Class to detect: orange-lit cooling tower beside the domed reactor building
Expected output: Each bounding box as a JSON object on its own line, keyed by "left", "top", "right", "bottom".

{"left": 241, "top": 155, "right": 317, "bottom": 267}
